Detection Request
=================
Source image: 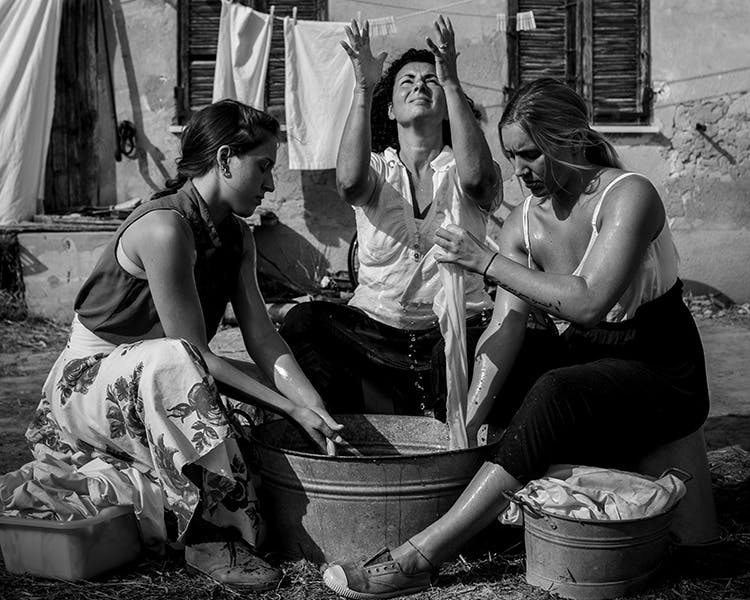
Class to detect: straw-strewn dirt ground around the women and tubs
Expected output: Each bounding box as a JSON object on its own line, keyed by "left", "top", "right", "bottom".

{"left": 0, "top": 299, "right": 750, "bottom": 600}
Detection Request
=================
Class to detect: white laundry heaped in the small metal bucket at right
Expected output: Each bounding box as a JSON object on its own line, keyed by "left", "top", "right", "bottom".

{"left": 500, "top": 467, "right": 686, "bottom": 525}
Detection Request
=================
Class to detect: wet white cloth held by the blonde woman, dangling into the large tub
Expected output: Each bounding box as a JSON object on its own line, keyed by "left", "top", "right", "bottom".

{"left": 433, "top": 202, "right": 469, "bottom": 450}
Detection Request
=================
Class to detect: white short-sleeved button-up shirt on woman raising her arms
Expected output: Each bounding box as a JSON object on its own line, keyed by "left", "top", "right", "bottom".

{"left": 349, "top": 146, "right": 499, "bottom": 329}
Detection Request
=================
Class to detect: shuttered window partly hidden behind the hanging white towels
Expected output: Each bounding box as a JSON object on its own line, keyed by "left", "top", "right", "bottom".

{"left": 175, "top": 0, "right": 328, "bottom": 124}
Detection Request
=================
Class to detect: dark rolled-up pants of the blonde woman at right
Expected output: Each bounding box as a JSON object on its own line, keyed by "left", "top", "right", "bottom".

{"left": 491, "top": 281, "right": 709, "bottom": 483}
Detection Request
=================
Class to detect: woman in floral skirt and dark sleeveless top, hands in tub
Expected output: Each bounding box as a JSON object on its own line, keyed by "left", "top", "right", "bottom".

{"left": 15, "top": 100, "right": 341, "bottom": 590}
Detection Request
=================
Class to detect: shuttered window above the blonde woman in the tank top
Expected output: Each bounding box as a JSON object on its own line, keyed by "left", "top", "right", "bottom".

{"left": 508, "top": 0, "right": 651, "bottom": 125}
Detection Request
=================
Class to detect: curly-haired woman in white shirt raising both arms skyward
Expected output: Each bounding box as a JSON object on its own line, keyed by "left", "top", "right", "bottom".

{"left": 280, "top": 17, "right": 502, "bottom": 416}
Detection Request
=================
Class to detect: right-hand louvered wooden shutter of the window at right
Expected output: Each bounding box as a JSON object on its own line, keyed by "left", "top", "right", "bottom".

{"left": 591, "top": 0, "right": 649, "bottom": 123}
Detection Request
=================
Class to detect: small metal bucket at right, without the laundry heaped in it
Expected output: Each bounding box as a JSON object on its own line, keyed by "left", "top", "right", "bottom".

{"left": 522, "top": 494, "right": 676, "bottom": 600}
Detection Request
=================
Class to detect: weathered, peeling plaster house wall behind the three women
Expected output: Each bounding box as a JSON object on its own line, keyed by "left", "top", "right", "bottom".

{"left": 106, "top": 0, "right": 750, "bottom": 302}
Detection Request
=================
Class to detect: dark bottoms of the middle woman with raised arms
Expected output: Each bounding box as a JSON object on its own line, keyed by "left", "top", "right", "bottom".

{"left": 279, "top": 302, "right": 490, "bottom": 419}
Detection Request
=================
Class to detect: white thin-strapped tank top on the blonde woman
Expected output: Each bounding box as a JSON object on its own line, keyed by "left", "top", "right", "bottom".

{"left": 523, "top": 173, "right": 679, "bottom": 323}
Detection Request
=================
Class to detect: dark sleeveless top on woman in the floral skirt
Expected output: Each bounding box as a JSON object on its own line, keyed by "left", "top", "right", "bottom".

{"left": 74, "top": 181, "right": 246, "bottom": 344}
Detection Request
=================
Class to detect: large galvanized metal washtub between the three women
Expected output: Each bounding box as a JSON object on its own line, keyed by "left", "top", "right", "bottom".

{"left": 251, "top": 415, "right": 499, "bottom": 564}
